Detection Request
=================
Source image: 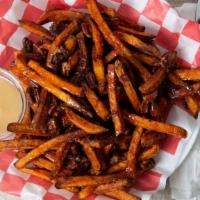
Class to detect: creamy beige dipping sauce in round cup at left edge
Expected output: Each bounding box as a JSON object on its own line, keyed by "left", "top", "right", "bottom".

{"left": 0, "top": 76, "right": 22, "bottom": 134}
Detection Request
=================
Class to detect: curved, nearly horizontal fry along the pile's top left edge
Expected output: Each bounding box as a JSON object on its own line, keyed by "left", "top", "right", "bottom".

{"left": 37, "top": 10, "right": 84, "bottom": 24}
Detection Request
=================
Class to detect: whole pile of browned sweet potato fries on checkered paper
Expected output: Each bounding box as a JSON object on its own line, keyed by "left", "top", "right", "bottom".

{"left": 0, "top": 0, "right": 200, "bottom": 200}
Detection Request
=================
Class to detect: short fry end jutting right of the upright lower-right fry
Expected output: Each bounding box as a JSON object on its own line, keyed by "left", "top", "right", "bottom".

{"left": 139, "top": 144, "right": 160, "bottom": 160}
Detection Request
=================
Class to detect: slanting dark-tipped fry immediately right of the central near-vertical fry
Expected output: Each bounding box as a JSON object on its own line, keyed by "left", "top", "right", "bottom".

{"left": 115, "top": 60, "right": 141, "bottom": 112}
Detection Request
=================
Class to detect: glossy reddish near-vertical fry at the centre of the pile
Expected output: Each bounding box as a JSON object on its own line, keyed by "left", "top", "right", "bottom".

{"left": 108, "top": 64, "right": 125, "bottom": 135}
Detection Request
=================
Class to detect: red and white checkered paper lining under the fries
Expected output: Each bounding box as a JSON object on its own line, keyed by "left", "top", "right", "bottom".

{"left": 0, "top": 0, "right": 200, "bottom": 200}
